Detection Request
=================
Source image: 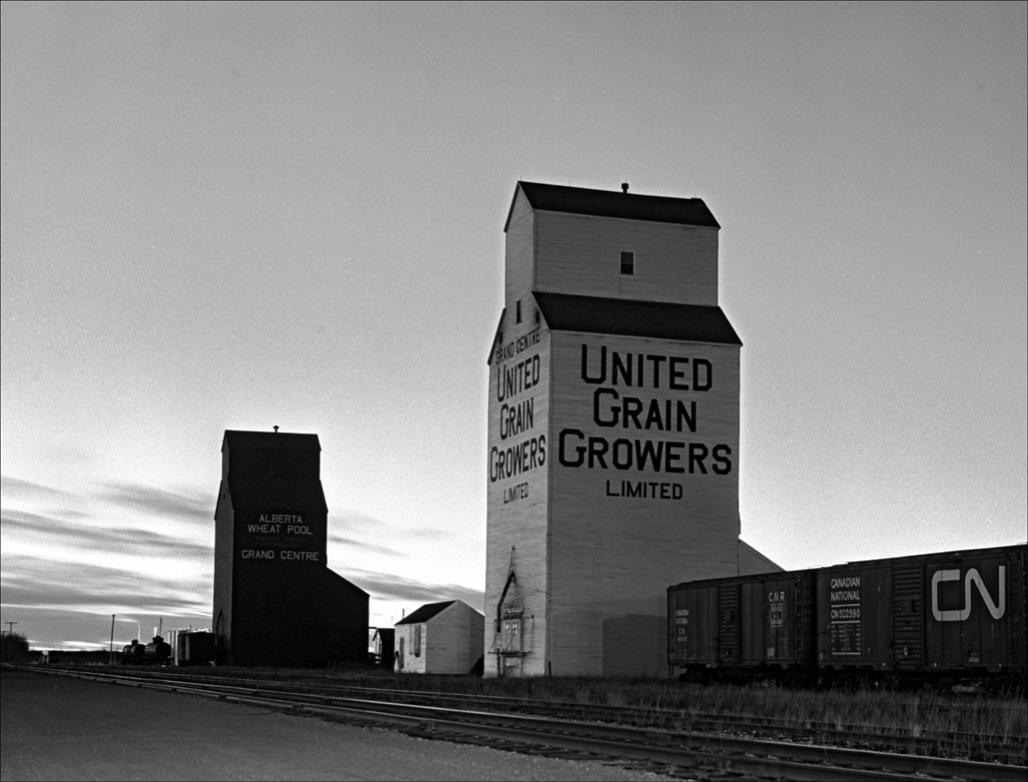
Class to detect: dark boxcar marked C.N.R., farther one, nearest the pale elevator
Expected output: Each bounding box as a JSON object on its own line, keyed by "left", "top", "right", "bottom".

{"left": 667, "top": 570, "right": 815, "bottom": 680}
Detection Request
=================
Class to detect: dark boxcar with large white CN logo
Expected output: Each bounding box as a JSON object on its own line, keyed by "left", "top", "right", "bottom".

{"left": 817, "top": 546, "right": 1026, "bottom": 678}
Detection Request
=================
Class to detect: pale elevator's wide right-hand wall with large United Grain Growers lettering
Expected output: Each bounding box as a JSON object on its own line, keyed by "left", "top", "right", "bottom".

{"left": 549, "top": 333, "right": 739, "bottom": 676}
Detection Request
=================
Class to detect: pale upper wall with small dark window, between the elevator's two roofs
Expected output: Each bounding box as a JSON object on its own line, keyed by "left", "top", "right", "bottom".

{"left": 533, "top": 212, "right": 718, "bottom": 306}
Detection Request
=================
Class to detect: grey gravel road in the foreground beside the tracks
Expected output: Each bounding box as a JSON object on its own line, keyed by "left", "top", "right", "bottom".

{"left": 0, "top": 670, "right": 670, "bottom": 782}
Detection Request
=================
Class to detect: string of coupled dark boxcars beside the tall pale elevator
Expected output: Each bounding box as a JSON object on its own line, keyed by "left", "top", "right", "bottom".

{"left": 667, "top": 545, "right": 1028, "bottom": 692}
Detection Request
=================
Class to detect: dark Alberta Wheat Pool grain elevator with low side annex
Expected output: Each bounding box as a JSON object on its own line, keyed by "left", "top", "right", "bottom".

{"left": 212, "top": 431, "right": 368, "bottom": 666}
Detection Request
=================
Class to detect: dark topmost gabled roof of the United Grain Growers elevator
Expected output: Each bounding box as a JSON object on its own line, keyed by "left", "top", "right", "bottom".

{"left": 504, "top": 182, "right": 721, "bottom": 233}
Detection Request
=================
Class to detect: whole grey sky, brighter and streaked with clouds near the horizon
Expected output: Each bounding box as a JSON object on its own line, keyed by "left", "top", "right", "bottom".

{"left": 0, "top": 0, "right": 1028, "bottom": 648}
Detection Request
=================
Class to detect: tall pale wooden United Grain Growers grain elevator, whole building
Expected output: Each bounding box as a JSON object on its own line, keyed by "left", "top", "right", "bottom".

{"left": 484, "top": 182, "right": 775, "bottom": 676}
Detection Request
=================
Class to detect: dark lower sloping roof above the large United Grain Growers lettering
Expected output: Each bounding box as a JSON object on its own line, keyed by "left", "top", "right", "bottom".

{"left": 531, "top": 291, "right": 742, "bottom": 345}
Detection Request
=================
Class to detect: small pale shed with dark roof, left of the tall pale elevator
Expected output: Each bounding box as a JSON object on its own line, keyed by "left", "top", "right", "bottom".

{"left": 394, "top": 600, "right": 485, "bottom": 674}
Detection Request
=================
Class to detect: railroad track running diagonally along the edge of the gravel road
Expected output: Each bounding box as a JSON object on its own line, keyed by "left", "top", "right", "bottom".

{"left": 10, "top": 666, "right": 1028, "bottom": 782}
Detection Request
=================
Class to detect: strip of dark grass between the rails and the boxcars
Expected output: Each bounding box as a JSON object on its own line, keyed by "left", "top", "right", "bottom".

{"left": 44, "top": 668, "right": 1028, "bottom": 765}
